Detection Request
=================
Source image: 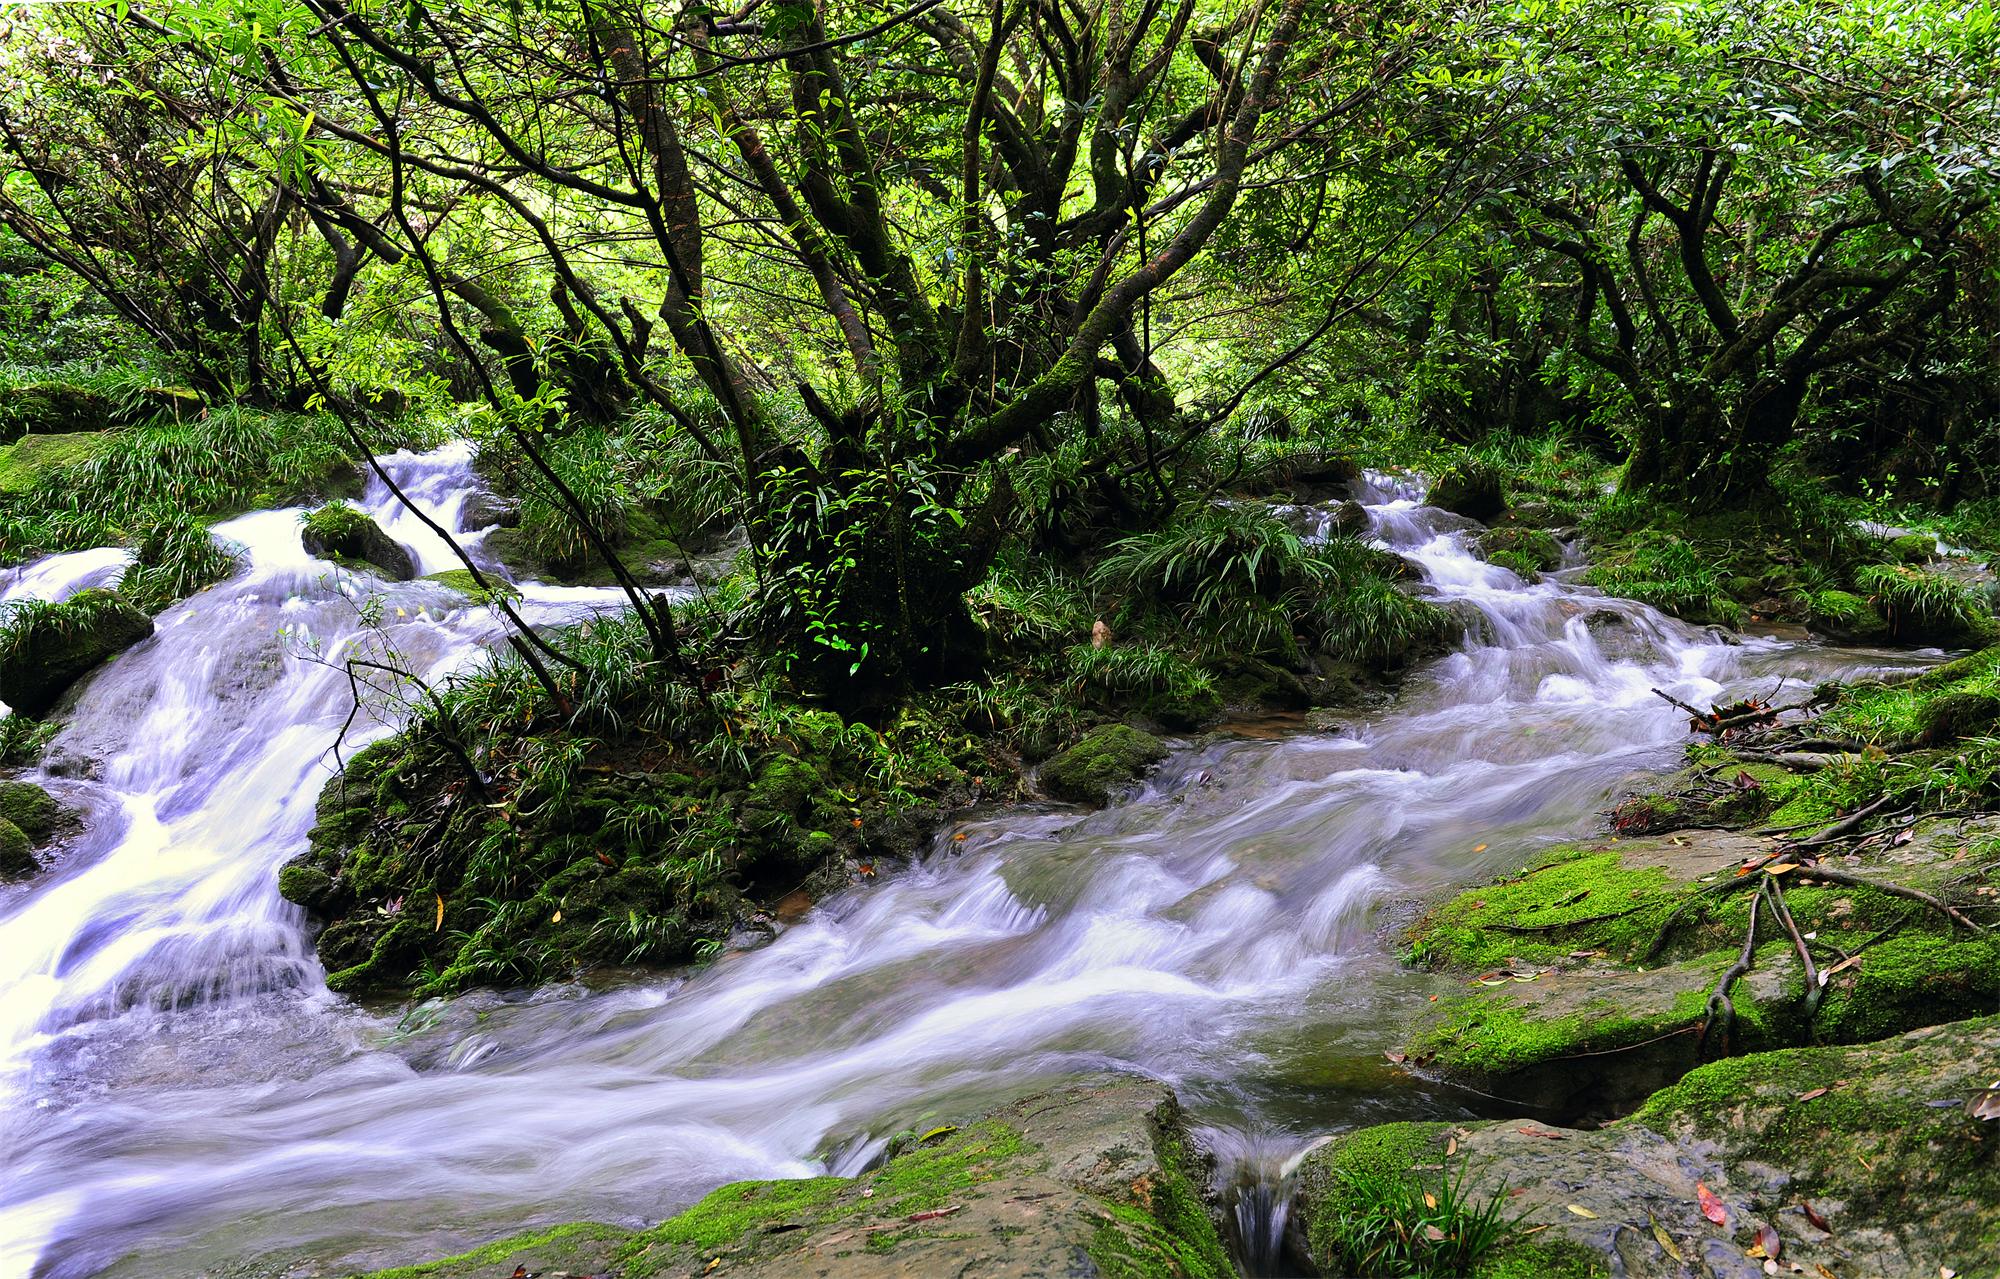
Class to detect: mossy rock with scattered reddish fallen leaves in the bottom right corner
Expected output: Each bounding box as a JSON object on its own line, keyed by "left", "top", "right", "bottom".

{"left": 1294, "top": 1017, "right": 2000, "bottom": 1279}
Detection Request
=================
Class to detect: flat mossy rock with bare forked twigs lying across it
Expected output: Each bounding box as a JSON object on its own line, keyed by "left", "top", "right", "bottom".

{"left": 1396, "top": 831, "right": 2000, "bottom": 1121}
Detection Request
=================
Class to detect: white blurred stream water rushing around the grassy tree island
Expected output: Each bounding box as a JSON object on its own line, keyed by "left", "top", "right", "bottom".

{"left": 0, "top": 448, "right": 1936, "bottom": 1279}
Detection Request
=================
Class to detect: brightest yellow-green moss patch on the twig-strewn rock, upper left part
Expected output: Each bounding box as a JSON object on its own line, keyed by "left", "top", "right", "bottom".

{"left": 1412, "top": 845, "right": 1678, "bottom": 969}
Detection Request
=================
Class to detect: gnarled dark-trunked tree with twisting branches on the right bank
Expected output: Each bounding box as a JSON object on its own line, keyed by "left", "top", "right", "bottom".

{"left": 1496, "top": 0, "right": 2000, "bottom": 508}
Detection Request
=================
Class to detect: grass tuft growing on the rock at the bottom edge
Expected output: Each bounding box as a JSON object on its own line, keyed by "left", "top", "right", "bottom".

{"left": 1312, "top": 1161, "right": 1520, "bottom": 1279}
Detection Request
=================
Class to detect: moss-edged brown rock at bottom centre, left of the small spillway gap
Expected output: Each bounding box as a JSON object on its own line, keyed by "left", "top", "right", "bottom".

{"left": 354, "top": 1075, "right": 1234, "bottom": 1279}
